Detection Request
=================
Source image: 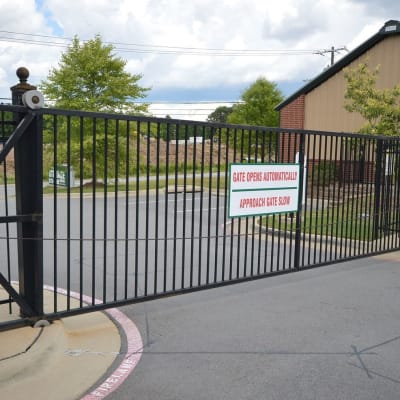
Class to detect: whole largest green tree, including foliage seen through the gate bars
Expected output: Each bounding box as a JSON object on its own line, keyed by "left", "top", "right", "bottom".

{"left": 40, "top": 35, "right": 149, "bottom": 181}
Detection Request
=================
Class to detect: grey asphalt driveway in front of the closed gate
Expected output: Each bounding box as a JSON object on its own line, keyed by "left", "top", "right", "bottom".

{"left": 109, "top": 253, "right": 400, "bottom": 400}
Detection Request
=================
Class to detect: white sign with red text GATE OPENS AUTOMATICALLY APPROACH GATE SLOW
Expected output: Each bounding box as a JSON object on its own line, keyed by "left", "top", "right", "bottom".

{"left": 229, "top": 163, "right": 300, "bottom": 218}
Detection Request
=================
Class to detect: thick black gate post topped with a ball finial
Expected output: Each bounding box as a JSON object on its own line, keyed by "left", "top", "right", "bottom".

{"left": 11, "top": 67, "right": 43, "bottom": 317}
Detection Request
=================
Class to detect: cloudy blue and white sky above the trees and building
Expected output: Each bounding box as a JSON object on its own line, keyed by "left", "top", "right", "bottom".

{"left": 0, "top": 0, "right": 400, "bottom": 120}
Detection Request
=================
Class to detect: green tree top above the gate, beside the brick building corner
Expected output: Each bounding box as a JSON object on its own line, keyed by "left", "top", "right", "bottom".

{"left": 228, "top": 78, "right": 283, "bottom": 127}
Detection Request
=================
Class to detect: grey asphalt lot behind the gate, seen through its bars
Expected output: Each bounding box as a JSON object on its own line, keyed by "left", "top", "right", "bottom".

{"left": 0, "top": 193, "right": 300, "bottom": 301}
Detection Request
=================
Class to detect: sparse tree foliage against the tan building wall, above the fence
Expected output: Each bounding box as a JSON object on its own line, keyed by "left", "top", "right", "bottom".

{"left": 344, "top": 63, "right": 400, "bottom": 136}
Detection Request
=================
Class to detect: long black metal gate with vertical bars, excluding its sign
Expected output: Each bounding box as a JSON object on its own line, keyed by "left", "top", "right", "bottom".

{"left": 0, "top": 99, "right": 400, "bottom": 326}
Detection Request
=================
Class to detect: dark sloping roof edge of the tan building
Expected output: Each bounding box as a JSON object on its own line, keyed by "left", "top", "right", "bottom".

{"left": 275, "top": 20, "right": 400, "bottom": 111}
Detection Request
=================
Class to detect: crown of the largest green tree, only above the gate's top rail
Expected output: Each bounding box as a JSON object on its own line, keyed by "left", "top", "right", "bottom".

{"left": 40, "top": 35, "right": 149, "bottom": 114}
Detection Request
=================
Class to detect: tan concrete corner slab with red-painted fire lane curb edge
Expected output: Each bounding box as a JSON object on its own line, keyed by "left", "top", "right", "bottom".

{"left": 0, "top": 289, "right": 143, "bottom": 400}
